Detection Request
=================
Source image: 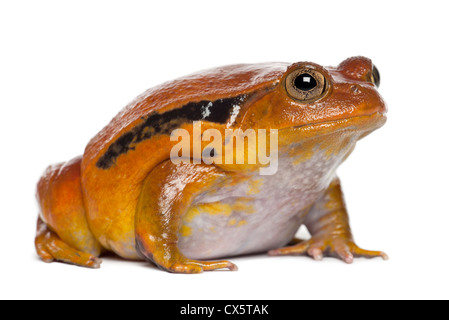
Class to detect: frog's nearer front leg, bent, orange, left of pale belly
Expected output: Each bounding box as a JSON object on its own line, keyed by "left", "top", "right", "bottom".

{"left": 136, "top": 161, "right": 237, "bottom": 273}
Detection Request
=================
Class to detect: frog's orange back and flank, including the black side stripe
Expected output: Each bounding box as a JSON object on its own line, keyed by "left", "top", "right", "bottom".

{"left": 81, "top": 63, "right": 288, "bottom": 258}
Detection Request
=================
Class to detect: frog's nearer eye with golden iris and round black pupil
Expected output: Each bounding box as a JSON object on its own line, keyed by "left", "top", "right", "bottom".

{"left": 285, "top": 68, "right": 327, "bottom": 102}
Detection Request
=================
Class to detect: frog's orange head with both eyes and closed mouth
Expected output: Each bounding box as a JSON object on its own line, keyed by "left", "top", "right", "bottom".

{"left": 242, "top": 57, "right": 387, "bottom": 142}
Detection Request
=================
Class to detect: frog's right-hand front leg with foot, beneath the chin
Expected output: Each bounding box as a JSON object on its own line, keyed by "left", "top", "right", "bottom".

{"left": 269, "top": 178, "right": 388, "bottom": 263}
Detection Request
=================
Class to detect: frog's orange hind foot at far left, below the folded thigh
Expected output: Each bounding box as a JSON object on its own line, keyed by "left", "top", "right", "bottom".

{"left": 35, "top": 218, "right": 102, "bottom": 269}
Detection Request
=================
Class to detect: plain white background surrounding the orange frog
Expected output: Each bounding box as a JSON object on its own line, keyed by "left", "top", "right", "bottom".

{"left": 0, "top": 0, "right": 449, "bottom": 299}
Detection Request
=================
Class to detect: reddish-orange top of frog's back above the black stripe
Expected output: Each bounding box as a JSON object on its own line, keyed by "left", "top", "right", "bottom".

{"left": 83, "top": 63, "right": 288, "bottom": 172}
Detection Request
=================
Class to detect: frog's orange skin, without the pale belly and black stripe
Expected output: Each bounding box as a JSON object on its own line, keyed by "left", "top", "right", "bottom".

{"left": 36, "top": 57, "right": 387, "bottom": 273}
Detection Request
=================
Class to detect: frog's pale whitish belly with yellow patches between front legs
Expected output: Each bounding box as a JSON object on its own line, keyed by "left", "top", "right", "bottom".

{"left": 178, "top": 154, "right": 340, "bottom": 259}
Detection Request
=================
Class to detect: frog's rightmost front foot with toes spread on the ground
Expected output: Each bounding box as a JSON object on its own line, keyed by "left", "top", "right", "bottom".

{"left": 268, "top": 237, "right": 388, "bottom": 264}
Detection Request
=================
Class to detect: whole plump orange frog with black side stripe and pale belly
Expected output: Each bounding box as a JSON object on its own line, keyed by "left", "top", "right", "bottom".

{"left": 35, "top": 56, "right": 388, "bottom": 273}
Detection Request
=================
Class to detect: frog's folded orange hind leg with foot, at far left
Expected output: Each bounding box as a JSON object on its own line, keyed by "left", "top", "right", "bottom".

{"left": 35, "top": 158, "right": 101, "bottom": 268}
